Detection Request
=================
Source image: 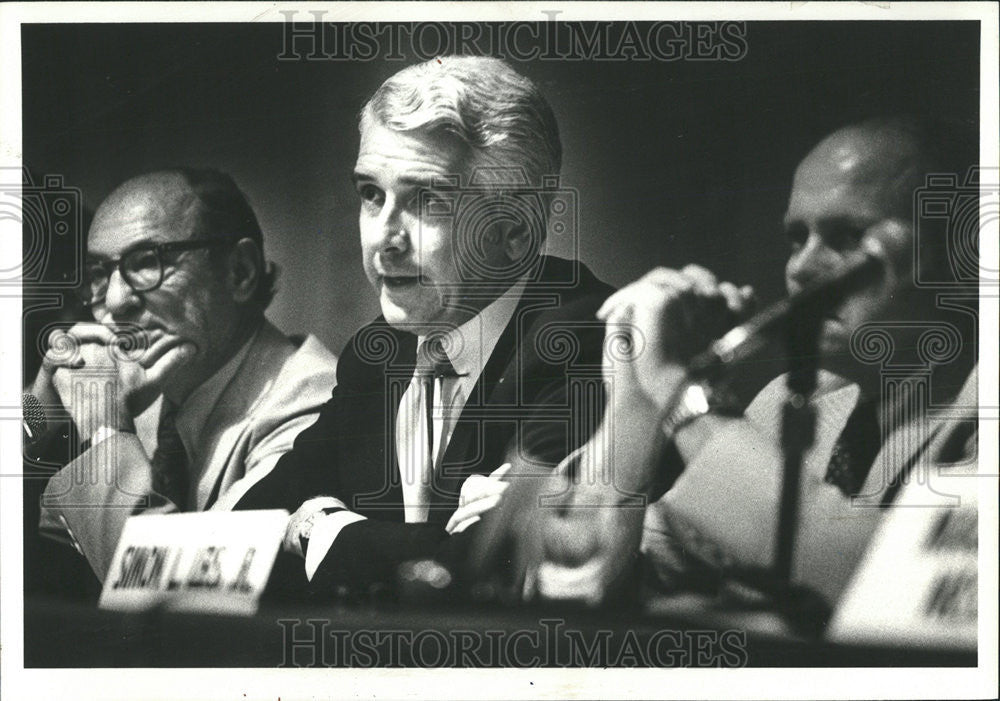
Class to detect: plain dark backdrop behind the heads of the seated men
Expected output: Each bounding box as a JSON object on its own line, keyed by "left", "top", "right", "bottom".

{"left": 22, "top": 22, "right": 979, "bottom": 355}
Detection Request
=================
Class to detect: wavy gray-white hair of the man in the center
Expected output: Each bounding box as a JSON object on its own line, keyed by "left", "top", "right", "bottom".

{"left": 359, "top": 56, "right": 562, "bottom": 187}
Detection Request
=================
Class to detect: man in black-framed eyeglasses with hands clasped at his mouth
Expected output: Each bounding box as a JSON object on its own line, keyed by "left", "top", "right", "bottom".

{"left": 26, "top": 168, "right": 336, "bottom": 579}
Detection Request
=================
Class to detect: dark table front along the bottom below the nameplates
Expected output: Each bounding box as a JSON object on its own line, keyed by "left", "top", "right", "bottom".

{"left": 24, "top": 598, "right": 977, "bottom": 668}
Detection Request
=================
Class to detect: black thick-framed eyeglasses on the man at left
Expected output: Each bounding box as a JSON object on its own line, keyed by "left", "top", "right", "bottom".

{"left": 77, "top": 237, "right": 236, "bottom": 306}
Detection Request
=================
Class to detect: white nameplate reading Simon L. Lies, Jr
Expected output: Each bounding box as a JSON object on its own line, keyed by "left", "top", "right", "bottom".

{"left": 99, "top": 509, "right": 288, "bottom": 615}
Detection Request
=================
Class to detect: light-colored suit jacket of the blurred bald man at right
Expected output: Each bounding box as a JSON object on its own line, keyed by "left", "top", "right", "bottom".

{"left": 641, "top": 370, "right": 977, "bottom": 604}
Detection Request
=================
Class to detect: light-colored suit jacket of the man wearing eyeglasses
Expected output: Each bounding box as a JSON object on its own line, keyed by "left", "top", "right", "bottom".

{"left": 40, "top": 322, "right": 337, "bottom": 581}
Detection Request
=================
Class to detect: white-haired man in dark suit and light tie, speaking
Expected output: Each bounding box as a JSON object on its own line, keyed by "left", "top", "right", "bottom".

{"left": 240, "top": 57, "right": 611, "bottom": 595}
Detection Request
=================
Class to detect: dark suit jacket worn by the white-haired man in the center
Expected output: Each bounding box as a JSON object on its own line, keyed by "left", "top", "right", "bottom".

{"left": 236, "top": 256, "right": 613, "bottom": 596}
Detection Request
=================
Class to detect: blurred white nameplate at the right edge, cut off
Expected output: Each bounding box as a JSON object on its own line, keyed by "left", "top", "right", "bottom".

{"left": 828, "top": 475, "right": 980, "bottom": 649}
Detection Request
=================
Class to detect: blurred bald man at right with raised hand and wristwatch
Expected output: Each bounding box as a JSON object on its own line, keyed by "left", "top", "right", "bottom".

{"left": 528, "top": 119, "right": 978, "bottom": 608}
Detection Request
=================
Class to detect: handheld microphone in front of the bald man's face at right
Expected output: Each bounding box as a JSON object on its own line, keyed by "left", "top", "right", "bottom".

{"left": 688, "top": 239, "right": 885, "bottom": 380}
